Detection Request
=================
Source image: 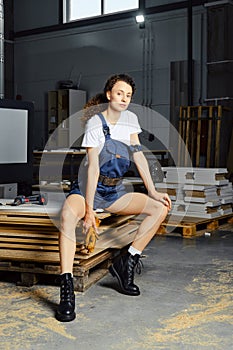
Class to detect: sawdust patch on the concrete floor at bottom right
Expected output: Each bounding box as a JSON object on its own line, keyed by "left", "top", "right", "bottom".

{"left": 111, "top": 260, "right": 233, "bottom": 350}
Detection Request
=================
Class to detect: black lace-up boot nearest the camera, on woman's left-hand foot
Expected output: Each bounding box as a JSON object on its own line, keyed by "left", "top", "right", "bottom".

{"left": 56, "top": 273, "right": 76, "bottom": 322}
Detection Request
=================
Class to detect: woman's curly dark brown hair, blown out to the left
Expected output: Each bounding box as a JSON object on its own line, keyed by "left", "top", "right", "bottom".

{"left": 83, "top": 74, "right": 136, "bottom": 122}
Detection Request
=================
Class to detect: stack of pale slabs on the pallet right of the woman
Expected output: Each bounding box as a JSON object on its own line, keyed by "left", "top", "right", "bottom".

{"left": 155, "top": 167, "right": 233, "bottom": 218}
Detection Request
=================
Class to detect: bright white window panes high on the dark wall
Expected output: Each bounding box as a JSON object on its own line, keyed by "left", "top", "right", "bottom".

{"left": 63, "top": 0, "right": 139, "bottom": 23}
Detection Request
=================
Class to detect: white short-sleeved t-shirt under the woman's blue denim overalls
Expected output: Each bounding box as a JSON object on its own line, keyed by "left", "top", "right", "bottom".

{"left": 82, "top": 110, "right": 142, "bottom": 148}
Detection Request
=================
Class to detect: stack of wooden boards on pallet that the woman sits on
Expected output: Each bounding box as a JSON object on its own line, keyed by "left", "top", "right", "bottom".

{"left": 0, "top": 200, "right": 138, "bottom": 292}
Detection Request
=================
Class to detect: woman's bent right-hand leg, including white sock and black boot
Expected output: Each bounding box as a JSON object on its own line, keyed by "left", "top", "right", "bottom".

{"left": 107, "top": 193, "right": 168, "bottom": 296}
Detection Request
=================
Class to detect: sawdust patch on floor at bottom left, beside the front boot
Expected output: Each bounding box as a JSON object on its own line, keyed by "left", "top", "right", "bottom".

{"left": 0, "top": 284, "right": 77, "bottom": 350}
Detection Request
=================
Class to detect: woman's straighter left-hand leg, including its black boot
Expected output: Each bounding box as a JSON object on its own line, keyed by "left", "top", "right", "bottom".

{"left": 56, "top": 194, "right": 85, "bottom": 322}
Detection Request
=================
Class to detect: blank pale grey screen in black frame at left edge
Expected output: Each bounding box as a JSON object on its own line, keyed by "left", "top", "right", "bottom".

{"left": 0, "top": 108, "right": 28, "bottom": 164}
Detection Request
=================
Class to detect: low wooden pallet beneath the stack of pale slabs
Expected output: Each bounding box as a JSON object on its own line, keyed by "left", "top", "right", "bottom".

{"left": 157, "top": 214, "right": 233, "bottom": 238}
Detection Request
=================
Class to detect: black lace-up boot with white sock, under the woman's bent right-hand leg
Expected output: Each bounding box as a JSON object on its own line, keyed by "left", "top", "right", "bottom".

{"left": 109, "top": 253, "right": 140, "bottom": 295}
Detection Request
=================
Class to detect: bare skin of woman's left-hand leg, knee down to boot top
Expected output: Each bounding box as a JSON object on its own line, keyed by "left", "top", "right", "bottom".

{"left": 59, "top": 194, "right": 85, "bottom": 273}
